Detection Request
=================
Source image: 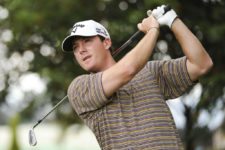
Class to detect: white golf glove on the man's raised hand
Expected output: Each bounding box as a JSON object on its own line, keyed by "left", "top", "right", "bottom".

{"left": 147, "top": 5, "right": 177, "bottom": 28}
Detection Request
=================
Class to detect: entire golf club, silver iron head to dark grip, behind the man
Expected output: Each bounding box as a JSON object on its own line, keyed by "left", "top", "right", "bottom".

{"left": 28, "top": 5, "right": 171, "bottom": 146}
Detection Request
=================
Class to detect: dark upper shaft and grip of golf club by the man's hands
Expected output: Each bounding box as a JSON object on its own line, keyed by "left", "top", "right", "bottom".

{"left": 112, "top": 5, "right": 171, "bottom": 57}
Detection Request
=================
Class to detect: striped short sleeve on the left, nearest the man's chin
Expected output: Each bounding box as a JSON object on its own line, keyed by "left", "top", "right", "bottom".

{"left": 68, "top": 72, "right": 108, "bottom": 115}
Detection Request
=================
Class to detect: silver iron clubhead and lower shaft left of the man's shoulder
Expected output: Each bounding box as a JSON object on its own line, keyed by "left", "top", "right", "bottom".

{"left": 28, "top": 95, "right": 68, "bottom": 146}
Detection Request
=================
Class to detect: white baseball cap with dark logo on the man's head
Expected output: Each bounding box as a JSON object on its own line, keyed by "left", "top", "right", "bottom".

{"left": 62, "top": 20, "right": 110, "bottom": 52}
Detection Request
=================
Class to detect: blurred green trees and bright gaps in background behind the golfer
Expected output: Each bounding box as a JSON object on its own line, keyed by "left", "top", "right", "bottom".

{"left": 0, "top": 0, "right": 225, "bottom": 150}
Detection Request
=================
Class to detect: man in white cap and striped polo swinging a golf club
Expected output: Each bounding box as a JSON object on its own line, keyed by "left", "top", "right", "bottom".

{"left": 62, "top": 5, "right": 213, "bottom": 150}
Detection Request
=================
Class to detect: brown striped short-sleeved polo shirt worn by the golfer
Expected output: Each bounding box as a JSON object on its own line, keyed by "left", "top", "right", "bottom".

{"left": 68, "top": 57, "right": 193, "bottom": 150}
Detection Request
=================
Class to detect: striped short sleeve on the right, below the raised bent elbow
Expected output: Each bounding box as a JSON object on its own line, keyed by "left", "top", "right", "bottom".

{"left": 147, "top": 56, "right": 194, "bottom": 99}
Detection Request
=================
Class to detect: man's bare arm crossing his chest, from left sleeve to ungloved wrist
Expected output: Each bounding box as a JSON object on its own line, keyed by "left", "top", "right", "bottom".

{"left": 102, "top": 28, "right": 159, "bottom": 97}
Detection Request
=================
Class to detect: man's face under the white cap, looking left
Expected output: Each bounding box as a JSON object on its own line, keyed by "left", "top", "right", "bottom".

{"left": 73, "top": 36, "right": 108, "bottom": 72}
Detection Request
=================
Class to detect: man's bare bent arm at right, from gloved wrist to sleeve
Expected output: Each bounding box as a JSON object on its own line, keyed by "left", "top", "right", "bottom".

{"left": 171, "top": 18, "right": 212, "bottom": 80}
